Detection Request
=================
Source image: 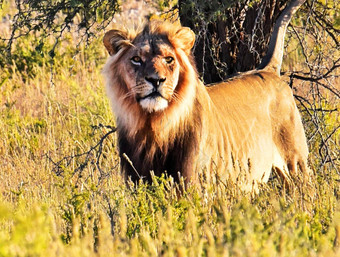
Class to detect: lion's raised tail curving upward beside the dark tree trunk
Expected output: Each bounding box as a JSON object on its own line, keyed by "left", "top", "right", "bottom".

{"left": 258, "top": 0, "right": 305, "bottom": 75}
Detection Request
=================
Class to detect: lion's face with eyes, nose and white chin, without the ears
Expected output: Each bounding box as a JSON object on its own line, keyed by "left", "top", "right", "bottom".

{"left": 124, "top": 38, "right": 179, "bottom": 113}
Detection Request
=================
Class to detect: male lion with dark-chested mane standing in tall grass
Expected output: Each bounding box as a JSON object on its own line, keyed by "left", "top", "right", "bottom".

{"left": 103, "top": 1, "right": 309, "bottom": 190}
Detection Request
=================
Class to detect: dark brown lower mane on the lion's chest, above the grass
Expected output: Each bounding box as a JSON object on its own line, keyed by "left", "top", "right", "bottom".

{"left": 119, "top": 125, "right": 197, "bottom": 181}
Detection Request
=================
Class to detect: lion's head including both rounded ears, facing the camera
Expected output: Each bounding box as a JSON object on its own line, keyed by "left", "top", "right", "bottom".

{"left": 104, "top": 21, "right": 195, "bottom": 114}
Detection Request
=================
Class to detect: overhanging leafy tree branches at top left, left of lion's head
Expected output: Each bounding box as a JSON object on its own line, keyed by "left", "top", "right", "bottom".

{"left": 3, "top": 0, "right": 119, "bottom": 51}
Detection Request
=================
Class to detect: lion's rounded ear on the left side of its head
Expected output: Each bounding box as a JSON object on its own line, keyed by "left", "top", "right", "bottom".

{"left": 103, "top": 29, "right": 131, "bottom": 55}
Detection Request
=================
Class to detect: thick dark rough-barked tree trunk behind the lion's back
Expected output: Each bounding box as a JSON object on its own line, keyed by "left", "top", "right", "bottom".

{"left": 179, "top": 0, "right": 287, "bottom": 83}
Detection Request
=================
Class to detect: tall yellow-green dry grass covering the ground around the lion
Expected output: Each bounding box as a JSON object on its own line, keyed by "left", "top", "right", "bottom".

{"left": 0, "top": 1, "right": 340, "bottom": 257}
